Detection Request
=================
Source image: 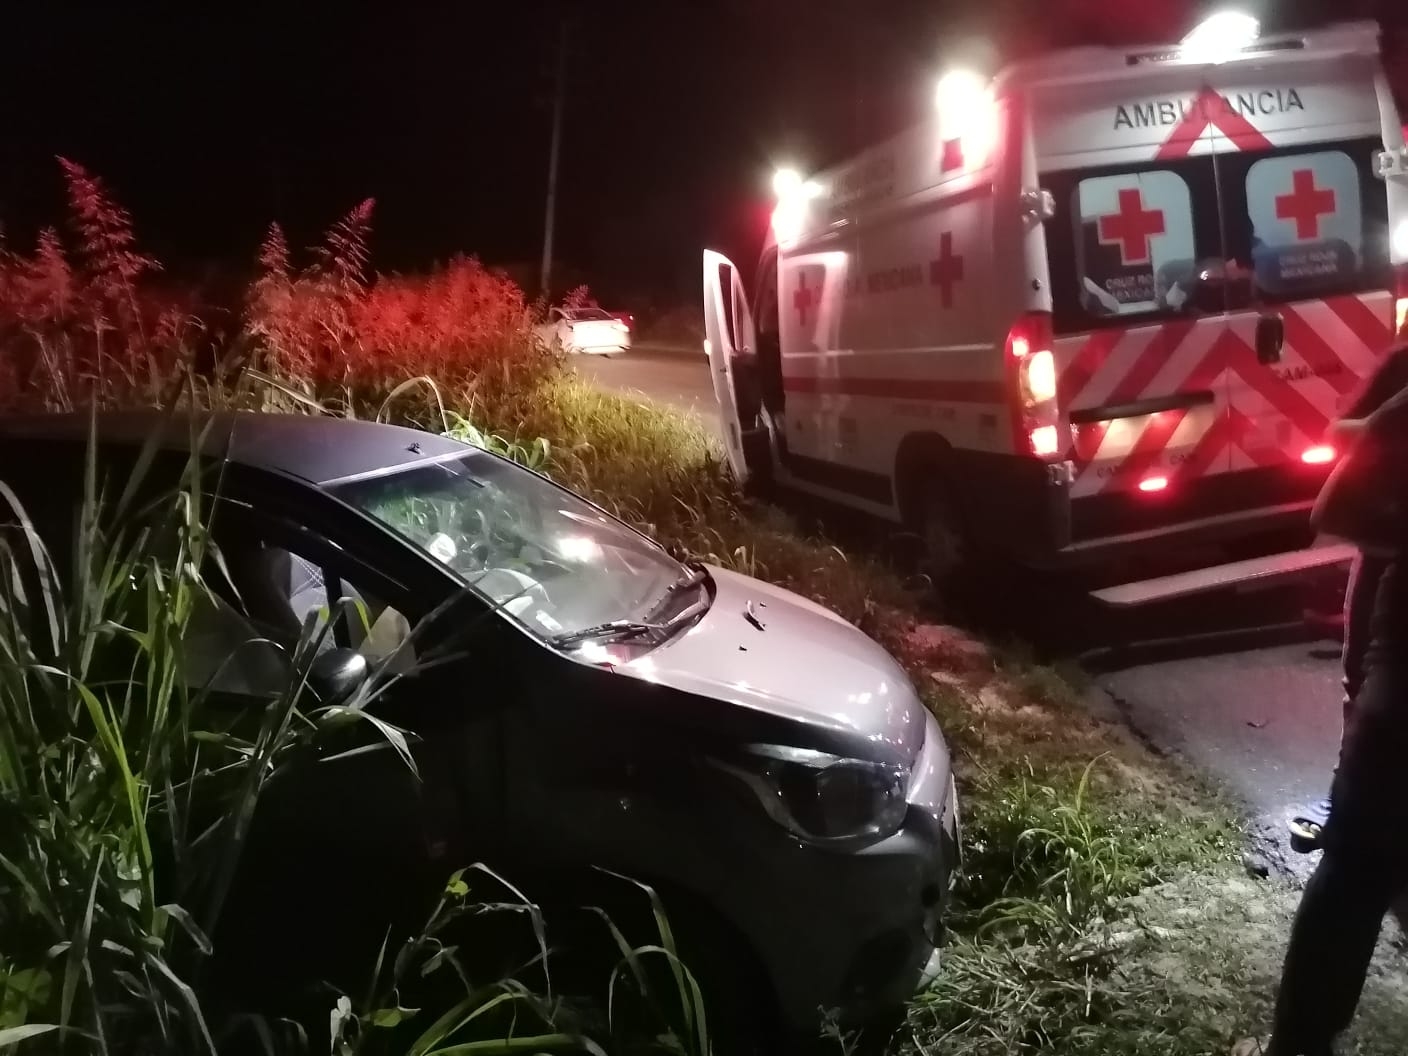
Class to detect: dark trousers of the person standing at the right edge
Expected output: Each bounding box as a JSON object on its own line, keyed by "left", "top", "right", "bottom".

{"left": 1270, "top": 562, "right": 1408, "bottom": 1056}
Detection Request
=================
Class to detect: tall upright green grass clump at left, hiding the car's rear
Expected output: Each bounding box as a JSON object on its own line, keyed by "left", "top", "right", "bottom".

{"left": 0, "top": 413, "right": 321, "bottom": 1052}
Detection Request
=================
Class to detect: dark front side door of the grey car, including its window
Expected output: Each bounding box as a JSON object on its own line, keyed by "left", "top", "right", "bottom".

{"left": 183, "top": 501, "right": 500, "bottom": 1002}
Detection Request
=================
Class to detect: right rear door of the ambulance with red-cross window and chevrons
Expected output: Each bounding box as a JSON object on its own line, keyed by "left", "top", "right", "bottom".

{"left": 1211, "top": 56, "right": 1400, "bottom": 470}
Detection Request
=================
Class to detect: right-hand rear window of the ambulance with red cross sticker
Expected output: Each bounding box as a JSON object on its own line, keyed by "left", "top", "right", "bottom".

{"left": 1218, "top": 139, "right": 1391, "bottom": 307}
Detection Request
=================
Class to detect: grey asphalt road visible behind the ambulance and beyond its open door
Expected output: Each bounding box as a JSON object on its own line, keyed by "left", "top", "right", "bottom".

{"left": 577, "top": 349, "right": 1340, "bottom": 873}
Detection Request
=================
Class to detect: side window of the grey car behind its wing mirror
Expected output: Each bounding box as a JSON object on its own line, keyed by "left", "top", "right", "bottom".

{"left": 183, "top": 539, "right": 415, "bottom": 696}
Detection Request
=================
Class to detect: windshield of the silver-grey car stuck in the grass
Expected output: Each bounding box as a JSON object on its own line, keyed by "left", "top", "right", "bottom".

{"left": 332, "top": 453, "right": 690, "bottom": 639}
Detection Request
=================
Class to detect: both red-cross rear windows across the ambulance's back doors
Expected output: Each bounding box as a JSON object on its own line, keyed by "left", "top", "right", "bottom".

{"left": 1042, "top": 139, "right": 1393, "bottom": 334}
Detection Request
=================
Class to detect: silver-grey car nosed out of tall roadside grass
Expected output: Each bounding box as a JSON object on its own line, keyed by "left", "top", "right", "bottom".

{"left": 0, "top": 413, "right": 957, "bottom": 1036}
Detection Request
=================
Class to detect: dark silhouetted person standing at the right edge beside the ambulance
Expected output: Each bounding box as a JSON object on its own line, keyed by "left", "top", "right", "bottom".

{"left": 1233, "top": 345, "right": 1408, "bottom": 1056}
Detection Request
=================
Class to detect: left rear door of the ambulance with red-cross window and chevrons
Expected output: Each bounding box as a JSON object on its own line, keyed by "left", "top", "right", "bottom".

{"left": 1032, "top": 72, "right": 1232, "bottom": 506}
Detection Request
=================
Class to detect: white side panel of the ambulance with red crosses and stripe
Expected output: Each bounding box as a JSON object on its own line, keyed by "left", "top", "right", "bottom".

{"left": 779, "top": 105, "right": 1021, "bottom": 520}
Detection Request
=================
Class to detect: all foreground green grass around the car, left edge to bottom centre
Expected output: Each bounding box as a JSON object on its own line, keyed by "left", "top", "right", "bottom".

{"left": 0, "top": 411, "right": 708, "bottom": 1056}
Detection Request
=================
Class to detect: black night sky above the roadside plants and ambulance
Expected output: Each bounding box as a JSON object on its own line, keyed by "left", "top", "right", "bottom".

{"left": 0, "top": 0, "right": 1408, "bottom": 301}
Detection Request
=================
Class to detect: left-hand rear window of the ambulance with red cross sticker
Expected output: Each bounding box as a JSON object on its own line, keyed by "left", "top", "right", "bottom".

{"left": 1043, "top": 158, "right": 1225, "bottom": 332}
